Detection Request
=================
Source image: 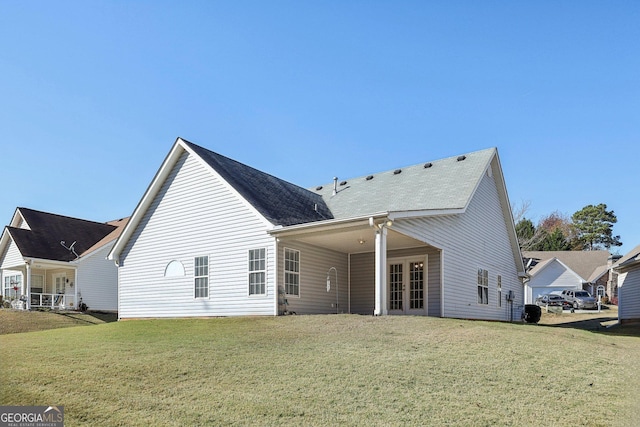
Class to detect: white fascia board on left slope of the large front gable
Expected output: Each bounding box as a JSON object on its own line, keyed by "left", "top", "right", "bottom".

{"left": 107, "top": 138, "right": 185, "bottom": 261}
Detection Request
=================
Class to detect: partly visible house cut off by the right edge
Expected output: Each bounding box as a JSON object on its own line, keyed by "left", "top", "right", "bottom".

{"left": 613, "top": 246, "right": 640, "bottom": 323}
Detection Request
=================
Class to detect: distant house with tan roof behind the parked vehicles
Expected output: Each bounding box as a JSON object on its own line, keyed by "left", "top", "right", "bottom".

{"left": 522, "top": 251, "right": 617, "bottom": 304}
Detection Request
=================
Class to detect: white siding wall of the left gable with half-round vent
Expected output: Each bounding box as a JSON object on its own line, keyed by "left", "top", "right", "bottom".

{"left": 118, "top": 153, "right": 277, "bottom": 318}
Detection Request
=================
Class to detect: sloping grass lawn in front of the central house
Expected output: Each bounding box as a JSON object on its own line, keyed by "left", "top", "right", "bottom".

{"left": 0, "top": 315, "right": 640, "bottom": 426}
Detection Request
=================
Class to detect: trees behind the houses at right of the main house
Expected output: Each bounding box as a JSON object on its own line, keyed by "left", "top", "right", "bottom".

{"left": 513, "top": 203, "right": 622, "bottom": 251}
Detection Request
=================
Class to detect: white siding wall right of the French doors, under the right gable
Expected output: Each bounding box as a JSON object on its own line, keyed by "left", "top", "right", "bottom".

{"left": 393, "top": 166, "right": 524, "bottom": 320}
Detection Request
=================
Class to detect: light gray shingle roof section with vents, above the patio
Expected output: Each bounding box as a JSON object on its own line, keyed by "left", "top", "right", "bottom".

{"left": 311, "top": 148, "right": 496, "bottom": 218}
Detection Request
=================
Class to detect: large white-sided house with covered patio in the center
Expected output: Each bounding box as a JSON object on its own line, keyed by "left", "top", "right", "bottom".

{"left": 109, "top": 138, "right": 524, "bottom": 320}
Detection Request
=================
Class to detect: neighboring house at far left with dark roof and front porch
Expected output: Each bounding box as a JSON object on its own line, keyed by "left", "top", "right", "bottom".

{"left": 0, "top": 208, "right": 127, "bottom": 311}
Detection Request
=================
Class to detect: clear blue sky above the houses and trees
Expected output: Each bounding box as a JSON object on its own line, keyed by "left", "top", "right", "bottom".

{"left": 0, "top": 0, "right": 640, "bottom": 253}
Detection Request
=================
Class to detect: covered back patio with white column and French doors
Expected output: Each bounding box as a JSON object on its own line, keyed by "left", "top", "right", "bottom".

{"left": 272, "top": 214, "right": 442, "bottom": 317}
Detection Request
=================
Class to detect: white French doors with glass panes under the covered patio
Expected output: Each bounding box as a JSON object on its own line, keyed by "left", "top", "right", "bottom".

{"left": 387, "top": 257, "right": 427, "bottom": 315}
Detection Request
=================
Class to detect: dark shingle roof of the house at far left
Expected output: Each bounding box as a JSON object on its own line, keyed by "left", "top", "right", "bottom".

{"left": 6, "top": 208, "right": 116, "bottom": 261}
